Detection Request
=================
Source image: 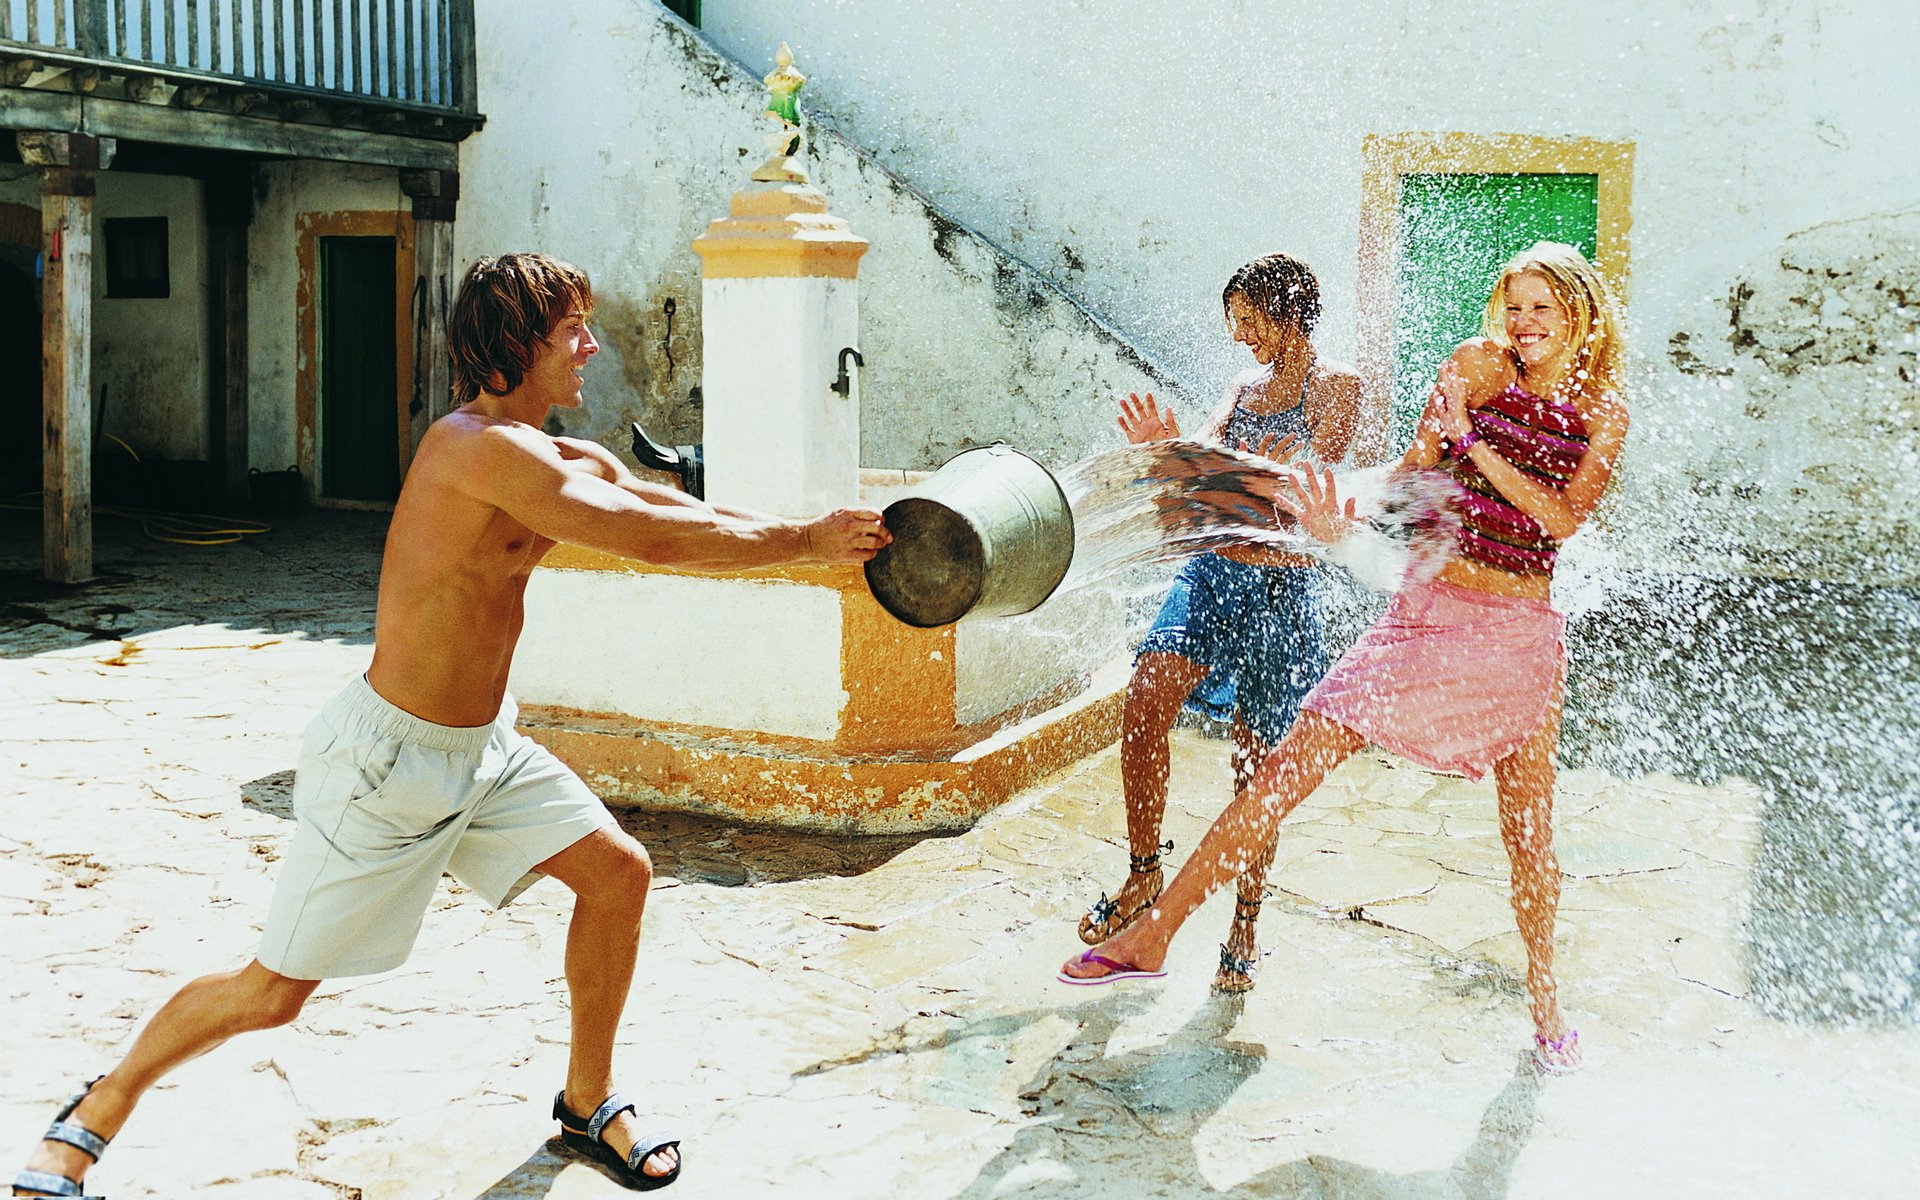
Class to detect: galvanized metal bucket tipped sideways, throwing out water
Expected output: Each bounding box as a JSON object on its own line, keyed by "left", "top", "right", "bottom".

{"left": 866, "top": 442, "right": 1073, "bottom": 628}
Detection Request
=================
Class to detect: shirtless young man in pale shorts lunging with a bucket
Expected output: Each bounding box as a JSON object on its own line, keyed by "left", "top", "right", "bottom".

{"left": 13, "top": 247, "right": 887, "bottom": 1196}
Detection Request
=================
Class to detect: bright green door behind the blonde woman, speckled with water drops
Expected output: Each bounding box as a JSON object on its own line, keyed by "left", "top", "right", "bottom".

{"left": 1392, "top": 175, "right": 1599, "bottom": 453}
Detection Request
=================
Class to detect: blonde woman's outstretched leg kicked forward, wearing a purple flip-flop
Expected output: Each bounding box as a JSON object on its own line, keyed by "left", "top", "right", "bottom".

{"left": 1062, "top": 712, "right": 1367, "bottom": 979}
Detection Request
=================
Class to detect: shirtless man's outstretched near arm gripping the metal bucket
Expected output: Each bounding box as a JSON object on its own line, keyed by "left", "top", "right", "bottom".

{"left": 468, "top": 426, "right": 887, "bottom": 570}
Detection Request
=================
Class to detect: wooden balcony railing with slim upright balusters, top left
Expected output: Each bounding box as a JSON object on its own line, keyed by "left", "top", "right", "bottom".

{"left": 0, "top": 0, "right": 478, "bottom": 117}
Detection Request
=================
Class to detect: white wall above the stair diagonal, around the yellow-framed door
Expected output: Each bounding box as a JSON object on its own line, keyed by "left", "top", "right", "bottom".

{"left": 703, "top": 0, "right": 1920, "bottom": 582}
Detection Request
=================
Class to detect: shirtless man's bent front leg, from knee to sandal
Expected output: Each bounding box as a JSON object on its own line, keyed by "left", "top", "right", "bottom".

{"left": 538, "top": 829, "right": 680, "bottom": 1175}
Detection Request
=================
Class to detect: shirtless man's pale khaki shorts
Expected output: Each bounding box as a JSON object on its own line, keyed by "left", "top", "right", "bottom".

{"left": 259, "top": 678, "right": 614, "bottom": 979}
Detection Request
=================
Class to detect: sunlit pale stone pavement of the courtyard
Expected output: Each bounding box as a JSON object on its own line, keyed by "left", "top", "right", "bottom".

{"left": 0, "top": 513, "right": 1920, "bottom": 1200}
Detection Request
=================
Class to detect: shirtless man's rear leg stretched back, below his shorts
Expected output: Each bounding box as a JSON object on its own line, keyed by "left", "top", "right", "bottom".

{"left": 21, "top": 960, "right": 321, "bottom": 1196}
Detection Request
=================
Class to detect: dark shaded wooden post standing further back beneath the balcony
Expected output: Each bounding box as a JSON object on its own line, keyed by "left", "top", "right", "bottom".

{"left": 205, "top": 169, "right": 253, "bottom": 505}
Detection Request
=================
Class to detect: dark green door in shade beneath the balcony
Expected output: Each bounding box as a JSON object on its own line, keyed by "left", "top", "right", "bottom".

{"left": 319, "top": 238, "right": 399, "bottom": 501}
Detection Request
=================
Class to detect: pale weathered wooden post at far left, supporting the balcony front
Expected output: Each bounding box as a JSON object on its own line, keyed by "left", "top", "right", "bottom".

{"left": 17, "top": 132, "right": 113, "bottom": 584}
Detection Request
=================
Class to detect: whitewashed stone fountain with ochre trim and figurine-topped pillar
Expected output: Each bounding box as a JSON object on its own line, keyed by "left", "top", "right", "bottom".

{"left": 511, "top": 48, "right": 1127, "bottom": 833}
